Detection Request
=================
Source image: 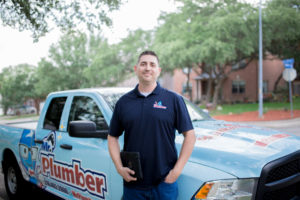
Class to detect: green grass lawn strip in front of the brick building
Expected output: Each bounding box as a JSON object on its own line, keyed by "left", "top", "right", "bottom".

{"left": 210, "top": 97, "right": 300, "bottom": 116}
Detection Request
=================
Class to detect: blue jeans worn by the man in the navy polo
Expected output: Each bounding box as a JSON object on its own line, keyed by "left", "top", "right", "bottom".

{"left": 123, "top": 182, "right": 178, "bottom": 200}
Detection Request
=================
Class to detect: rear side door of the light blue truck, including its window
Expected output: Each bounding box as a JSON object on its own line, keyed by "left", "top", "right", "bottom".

{"left": 35, "top": 96, "right": 69, "bottom": 198}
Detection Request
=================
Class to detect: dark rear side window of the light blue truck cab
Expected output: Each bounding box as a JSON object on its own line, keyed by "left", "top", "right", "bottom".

{"left": 43, "top": 97, "right": 67, "bottom": 131}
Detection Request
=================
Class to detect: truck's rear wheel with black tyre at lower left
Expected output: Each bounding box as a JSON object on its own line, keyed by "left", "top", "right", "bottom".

{"left": 4, "top": 161, "right": 29, "bottom": 200}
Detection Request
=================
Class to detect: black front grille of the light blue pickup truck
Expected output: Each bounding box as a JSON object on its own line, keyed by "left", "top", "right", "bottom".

{"left": 255, "top": 151, "right": 300, "bottom": 200}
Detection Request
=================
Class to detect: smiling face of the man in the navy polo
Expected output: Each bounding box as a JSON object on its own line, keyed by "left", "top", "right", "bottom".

{"left": 134, "top": 55, "right": 161, "bottom": 84}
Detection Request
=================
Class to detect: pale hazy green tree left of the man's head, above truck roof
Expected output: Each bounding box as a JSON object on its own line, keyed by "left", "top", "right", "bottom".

{"left": 84, "top": 29, "right": 153, "bottom": 87}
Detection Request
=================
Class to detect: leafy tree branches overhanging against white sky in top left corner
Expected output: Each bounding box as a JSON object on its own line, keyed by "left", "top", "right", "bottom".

{"left": 0, "top": 0, "right": 120, "bottom": 39}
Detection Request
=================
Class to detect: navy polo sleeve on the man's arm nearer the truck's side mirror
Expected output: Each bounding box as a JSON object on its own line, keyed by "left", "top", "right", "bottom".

{"left": 108, "top": 101, "right": 124, "bottom": 137}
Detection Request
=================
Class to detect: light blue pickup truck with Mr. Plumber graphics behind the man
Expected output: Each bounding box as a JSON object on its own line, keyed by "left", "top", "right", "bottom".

{"left": 0, "top": 88, "right": 300, "bottom": 200}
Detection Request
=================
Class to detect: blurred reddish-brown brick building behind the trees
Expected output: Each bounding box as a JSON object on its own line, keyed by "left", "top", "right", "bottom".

{"left": 119, "top": 55, "right": 300, "bottom": 103}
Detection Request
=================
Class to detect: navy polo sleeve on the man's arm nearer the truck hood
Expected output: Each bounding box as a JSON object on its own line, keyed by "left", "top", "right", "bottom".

{"left": 175, "top": 96, "right": 194, "bottom": 133}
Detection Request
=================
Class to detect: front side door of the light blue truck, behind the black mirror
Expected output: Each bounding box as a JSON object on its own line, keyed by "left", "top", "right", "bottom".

{"left": 61, "top": 95, "right": 122, "bottom": 199}
